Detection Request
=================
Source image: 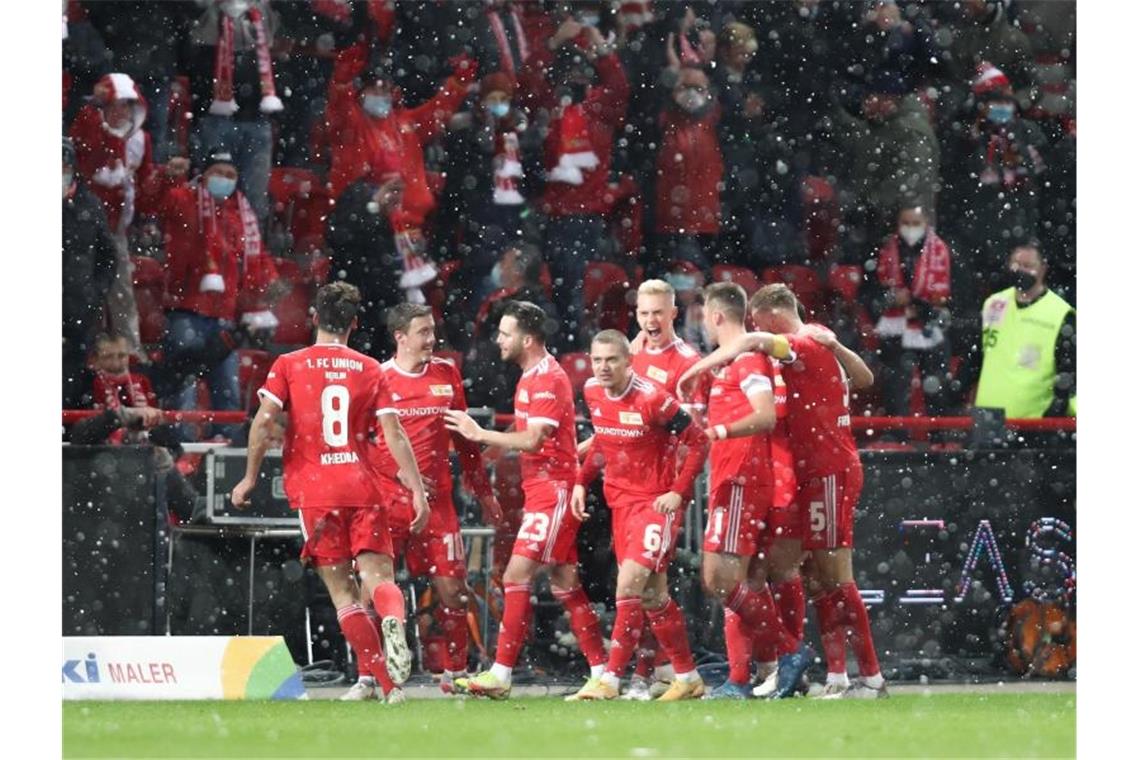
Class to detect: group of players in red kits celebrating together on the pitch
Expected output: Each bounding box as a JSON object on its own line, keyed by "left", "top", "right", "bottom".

{"left": 231, "top": 280, "right": 887, "bottom": 702}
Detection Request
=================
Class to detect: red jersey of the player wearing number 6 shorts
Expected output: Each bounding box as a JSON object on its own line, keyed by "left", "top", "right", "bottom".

{"left": 583, "top": 374, "right": 681, "bottom": 509}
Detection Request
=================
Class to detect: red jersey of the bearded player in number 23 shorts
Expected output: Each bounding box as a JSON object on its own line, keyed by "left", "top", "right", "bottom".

{"left": 514, "top": 353, "right": 578, "bottom": 487}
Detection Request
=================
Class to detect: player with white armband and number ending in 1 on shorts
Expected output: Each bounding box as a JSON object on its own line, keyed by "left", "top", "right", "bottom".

{"left": 682, "top": 283, "right": 811, "bottom": 698}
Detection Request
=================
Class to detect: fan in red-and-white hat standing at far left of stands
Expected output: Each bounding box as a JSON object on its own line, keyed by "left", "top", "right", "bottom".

{"left": 71, "top": 73, "right": 186, "bottom": 358}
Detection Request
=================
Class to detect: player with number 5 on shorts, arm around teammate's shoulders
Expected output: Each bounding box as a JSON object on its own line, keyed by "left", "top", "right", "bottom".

{"left": 682, "top": 285, "right": 887, "bottom": 698}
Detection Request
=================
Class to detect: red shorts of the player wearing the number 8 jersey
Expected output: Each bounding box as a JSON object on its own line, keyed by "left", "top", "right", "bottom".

{"left": 300, "top": 507, "right": 392, "bottom": 566}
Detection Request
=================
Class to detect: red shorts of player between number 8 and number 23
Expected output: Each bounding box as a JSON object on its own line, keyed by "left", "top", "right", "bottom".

{"left": 388, "top": 492, "right": 467, "bottom": 578}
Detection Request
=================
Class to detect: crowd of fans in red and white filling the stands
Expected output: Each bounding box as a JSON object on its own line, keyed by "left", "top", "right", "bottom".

{"left": 63, "top": 0, "right": 1076, "bottom": 434}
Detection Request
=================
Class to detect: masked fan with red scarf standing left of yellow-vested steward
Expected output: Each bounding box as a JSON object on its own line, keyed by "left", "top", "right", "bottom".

{"left": 874, "top": 204, "right": 951, "bottom": 417}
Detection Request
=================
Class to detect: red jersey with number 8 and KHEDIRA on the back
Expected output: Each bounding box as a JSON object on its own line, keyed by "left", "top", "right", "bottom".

{"left": 258, "top": 343, "right": 396, "bottom": 509}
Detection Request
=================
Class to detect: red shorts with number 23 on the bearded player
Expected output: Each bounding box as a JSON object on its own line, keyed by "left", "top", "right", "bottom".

{"left": 511, "top": 481, "right": 581, "bottom": 565}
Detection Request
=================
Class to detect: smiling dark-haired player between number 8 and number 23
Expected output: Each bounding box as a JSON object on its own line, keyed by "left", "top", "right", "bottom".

{"left": 376, "top": 303, "right": 503, "bottom": 694}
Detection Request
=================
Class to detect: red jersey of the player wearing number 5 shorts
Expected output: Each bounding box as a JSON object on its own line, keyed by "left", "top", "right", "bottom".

{"left": 783, "top": 325, "right": 858, "bottom": 481}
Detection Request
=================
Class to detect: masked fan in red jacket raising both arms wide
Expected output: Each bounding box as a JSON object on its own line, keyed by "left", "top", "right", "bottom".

{"left": 325, "top": 42, "right": 477, "bottom": 302}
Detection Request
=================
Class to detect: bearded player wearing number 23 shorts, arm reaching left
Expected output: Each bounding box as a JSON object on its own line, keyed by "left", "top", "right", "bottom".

{"left": 445, "top": 301, "right": 605, "bottom": 700}
